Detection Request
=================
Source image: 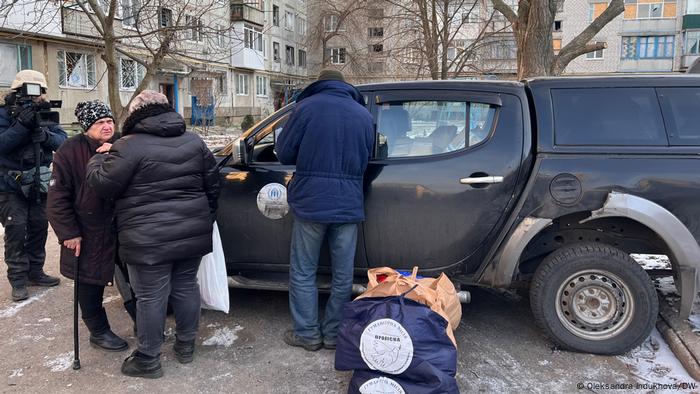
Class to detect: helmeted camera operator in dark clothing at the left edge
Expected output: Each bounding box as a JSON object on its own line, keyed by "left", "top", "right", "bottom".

{"left": 0, "top": 70, "right": 66, "bottom": 301}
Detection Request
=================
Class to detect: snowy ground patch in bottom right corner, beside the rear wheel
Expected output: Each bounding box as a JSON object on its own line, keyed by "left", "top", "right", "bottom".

{"left": 617, "top": 328, "right": 700, "bottom": 393}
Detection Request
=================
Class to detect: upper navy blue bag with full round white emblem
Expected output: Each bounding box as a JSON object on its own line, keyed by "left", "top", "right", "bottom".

{"left": 335, "top": 288, "right": 457, "bottom": 382}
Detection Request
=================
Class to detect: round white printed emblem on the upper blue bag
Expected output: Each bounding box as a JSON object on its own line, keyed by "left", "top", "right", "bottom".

{"left": 360, "top": 319, "right": 413, "bottom": 375}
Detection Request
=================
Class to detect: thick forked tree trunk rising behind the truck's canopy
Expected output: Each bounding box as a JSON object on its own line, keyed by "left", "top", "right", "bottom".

{"left": 491, "top": 0, "right": 625, "bottom": 79}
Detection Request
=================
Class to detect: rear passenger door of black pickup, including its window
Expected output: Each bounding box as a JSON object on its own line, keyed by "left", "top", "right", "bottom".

{"left": 363, "top": 90, "right": 523, "bottom": 269}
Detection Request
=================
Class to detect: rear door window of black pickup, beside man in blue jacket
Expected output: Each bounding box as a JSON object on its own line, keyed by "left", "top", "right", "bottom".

{"left": 377, "top": 101, "right": 496, "bottom": 158}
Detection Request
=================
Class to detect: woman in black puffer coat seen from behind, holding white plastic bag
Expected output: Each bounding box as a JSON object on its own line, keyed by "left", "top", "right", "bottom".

{"left": 86, "top": 90, "right": 219, "bottom": 378}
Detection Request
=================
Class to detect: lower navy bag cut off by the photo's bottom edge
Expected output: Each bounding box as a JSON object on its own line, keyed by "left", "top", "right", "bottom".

{"left": 348, "top": 370, "right": 459, "bottom": 394}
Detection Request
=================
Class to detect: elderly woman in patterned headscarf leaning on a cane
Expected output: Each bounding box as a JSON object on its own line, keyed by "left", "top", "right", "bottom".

{"left": 47, "top": 101, "right": 129, "bottom": 351}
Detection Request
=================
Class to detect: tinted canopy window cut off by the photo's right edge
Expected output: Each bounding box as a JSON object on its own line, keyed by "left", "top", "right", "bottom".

{"left": 657, "top": 87, "right": 700, "bottom": 145}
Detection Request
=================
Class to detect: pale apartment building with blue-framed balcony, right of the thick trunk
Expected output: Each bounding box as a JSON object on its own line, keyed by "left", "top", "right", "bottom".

{"left": 554, "top": 0, "right": 700, "bottom": 74}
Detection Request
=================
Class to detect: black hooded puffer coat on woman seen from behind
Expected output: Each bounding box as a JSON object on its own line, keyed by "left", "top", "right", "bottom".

{"left": 86, "top": 104, "right": 219, "bottom": 265}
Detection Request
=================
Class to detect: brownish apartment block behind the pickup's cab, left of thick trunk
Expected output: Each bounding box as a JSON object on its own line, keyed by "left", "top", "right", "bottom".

{"left": 309, "top": 0, "right": 517, "bottom": 83}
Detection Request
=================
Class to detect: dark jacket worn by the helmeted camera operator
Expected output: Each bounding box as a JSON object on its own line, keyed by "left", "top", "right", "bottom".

{"left": 0, "top": 105, "right": 67, "bottom": 192}
